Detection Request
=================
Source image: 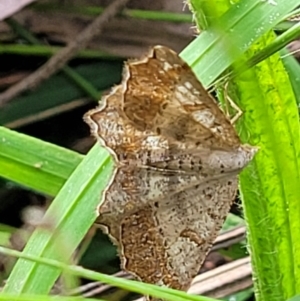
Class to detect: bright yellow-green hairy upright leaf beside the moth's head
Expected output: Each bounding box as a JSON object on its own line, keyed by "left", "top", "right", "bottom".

{"left": 235, "top": 34, "right": 300, "bottom": 301}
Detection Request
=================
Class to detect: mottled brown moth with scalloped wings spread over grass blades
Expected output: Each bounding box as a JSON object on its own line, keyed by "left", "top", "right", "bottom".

{"left": 84, "top": 46, "right": 257, "bottom": 298}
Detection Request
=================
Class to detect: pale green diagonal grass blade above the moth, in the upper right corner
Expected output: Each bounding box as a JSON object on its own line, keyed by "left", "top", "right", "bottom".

{"left": 181, "top": 0, "right": 300, "bottom": 87}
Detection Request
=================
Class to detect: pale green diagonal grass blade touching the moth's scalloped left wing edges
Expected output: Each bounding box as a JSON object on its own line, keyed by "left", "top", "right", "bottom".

{"left": 3, "top": 145, "right": 112, "bottom": 294}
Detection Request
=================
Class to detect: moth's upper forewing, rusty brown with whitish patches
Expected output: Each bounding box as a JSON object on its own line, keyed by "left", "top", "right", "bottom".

{"left": 123, "top": 46, "right": 240, "bottom": 148}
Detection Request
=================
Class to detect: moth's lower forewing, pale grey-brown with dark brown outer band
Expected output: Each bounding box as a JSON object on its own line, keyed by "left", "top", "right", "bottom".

{"left": 120, "top": 177, "right": 237, "bottom": 290}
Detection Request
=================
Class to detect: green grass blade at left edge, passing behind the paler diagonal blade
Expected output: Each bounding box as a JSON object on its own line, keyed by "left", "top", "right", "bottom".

{"left": 0, "top": 127, "right": 83, "bottom": 196}
